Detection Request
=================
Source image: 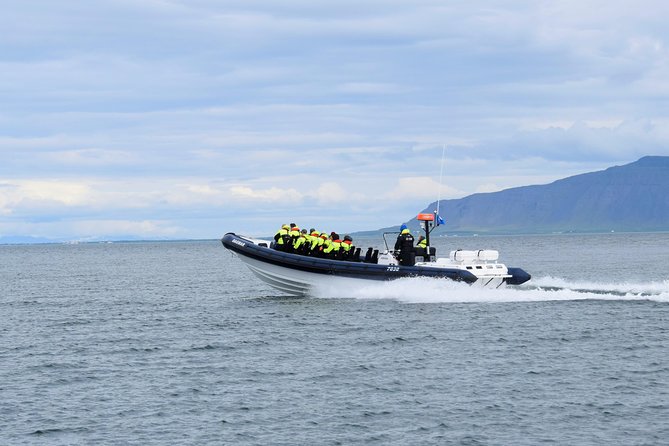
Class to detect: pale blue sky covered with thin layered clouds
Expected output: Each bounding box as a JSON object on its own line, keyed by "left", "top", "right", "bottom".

{"left": 0, "top": 0, "right": 669, "bottom": 240}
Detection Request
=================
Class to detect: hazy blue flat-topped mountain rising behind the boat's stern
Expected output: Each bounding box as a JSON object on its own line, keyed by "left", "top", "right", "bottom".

{"left": 407, "top": 156, "right": 669, "bottom": 234}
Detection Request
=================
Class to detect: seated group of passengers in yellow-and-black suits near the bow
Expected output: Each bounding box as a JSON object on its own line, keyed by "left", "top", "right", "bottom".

{"left": 274, "top": 223, "right": 360, "bottom": 261}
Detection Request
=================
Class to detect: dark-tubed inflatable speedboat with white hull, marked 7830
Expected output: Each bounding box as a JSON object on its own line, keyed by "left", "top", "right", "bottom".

{"left": 221, "top": 214, "right": 531, "bottom": 296}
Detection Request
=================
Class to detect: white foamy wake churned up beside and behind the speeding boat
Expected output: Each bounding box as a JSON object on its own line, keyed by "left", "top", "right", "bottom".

{"left": 314, "top": 277, "right": 669, "bottom": 303}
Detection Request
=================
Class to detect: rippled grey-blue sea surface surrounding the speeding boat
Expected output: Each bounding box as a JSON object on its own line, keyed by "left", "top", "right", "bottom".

{"left": 0, "top": 233, "right": 669, "bottom": 445}
